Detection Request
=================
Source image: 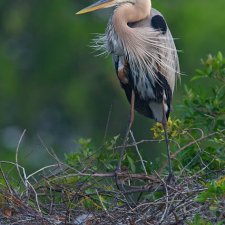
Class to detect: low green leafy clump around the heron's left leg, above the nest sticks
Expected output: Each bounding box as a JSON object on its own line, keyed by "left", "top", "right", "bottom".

{"left": 65, "top": 135, "right": 142, "bottom": 172}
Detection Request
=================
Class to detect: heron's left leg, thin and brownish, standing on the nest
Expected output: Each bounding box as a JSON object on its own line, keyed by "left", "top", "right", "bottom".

{"left": 116, "top": 89, "right": 135, "bottom": 172}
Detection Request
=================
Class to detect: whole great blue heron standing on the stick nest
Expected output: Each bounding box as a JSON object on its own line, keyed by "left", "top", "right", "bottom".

{"left": 77, "top": 0, "right": 180, "bottom": 178}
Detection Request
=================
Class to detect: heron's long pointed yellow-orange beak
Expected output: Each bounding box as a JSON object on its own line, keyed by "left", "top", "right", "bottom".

{"left": 76, "top": 0, "right": 116, "bottom": 15}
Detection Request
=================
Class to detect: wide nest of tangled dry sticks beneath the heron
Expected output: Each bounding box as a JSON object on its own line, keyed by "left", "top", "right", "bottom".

{"left": 0, "top": 130, "right": 225, "bottom": 225}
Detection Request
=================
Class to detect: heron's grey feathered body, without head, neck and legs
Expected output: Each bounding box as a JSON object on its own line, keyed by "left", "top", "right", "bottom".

{"left": 102, "top": 7, "right": 179, "bottom": 122}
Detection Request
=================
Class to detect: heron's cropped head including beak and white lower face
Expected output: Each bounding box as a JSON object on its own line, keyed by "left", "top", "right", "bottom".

{"left": 76, "top": 0, "right": 135, "bottom": 14}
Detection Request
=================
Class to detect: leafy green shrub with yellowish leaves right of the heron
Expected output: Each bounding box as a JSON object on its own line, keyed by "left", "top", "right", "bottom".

{"left": 151, "top": 52, "right": 225, "bottom": 172}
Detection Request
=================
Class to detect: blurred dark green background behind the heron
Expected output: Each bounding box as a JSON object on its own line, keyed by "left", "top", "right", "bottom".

{"left": 0, "top": 0, "right": 225, "bottom": 169}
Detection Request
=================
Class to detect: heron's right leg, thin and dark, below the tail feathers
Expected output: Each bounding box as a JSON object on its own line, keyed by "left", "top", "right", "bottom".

{"left": 162, "top": 101, "right": 175, "bottom": 183}
